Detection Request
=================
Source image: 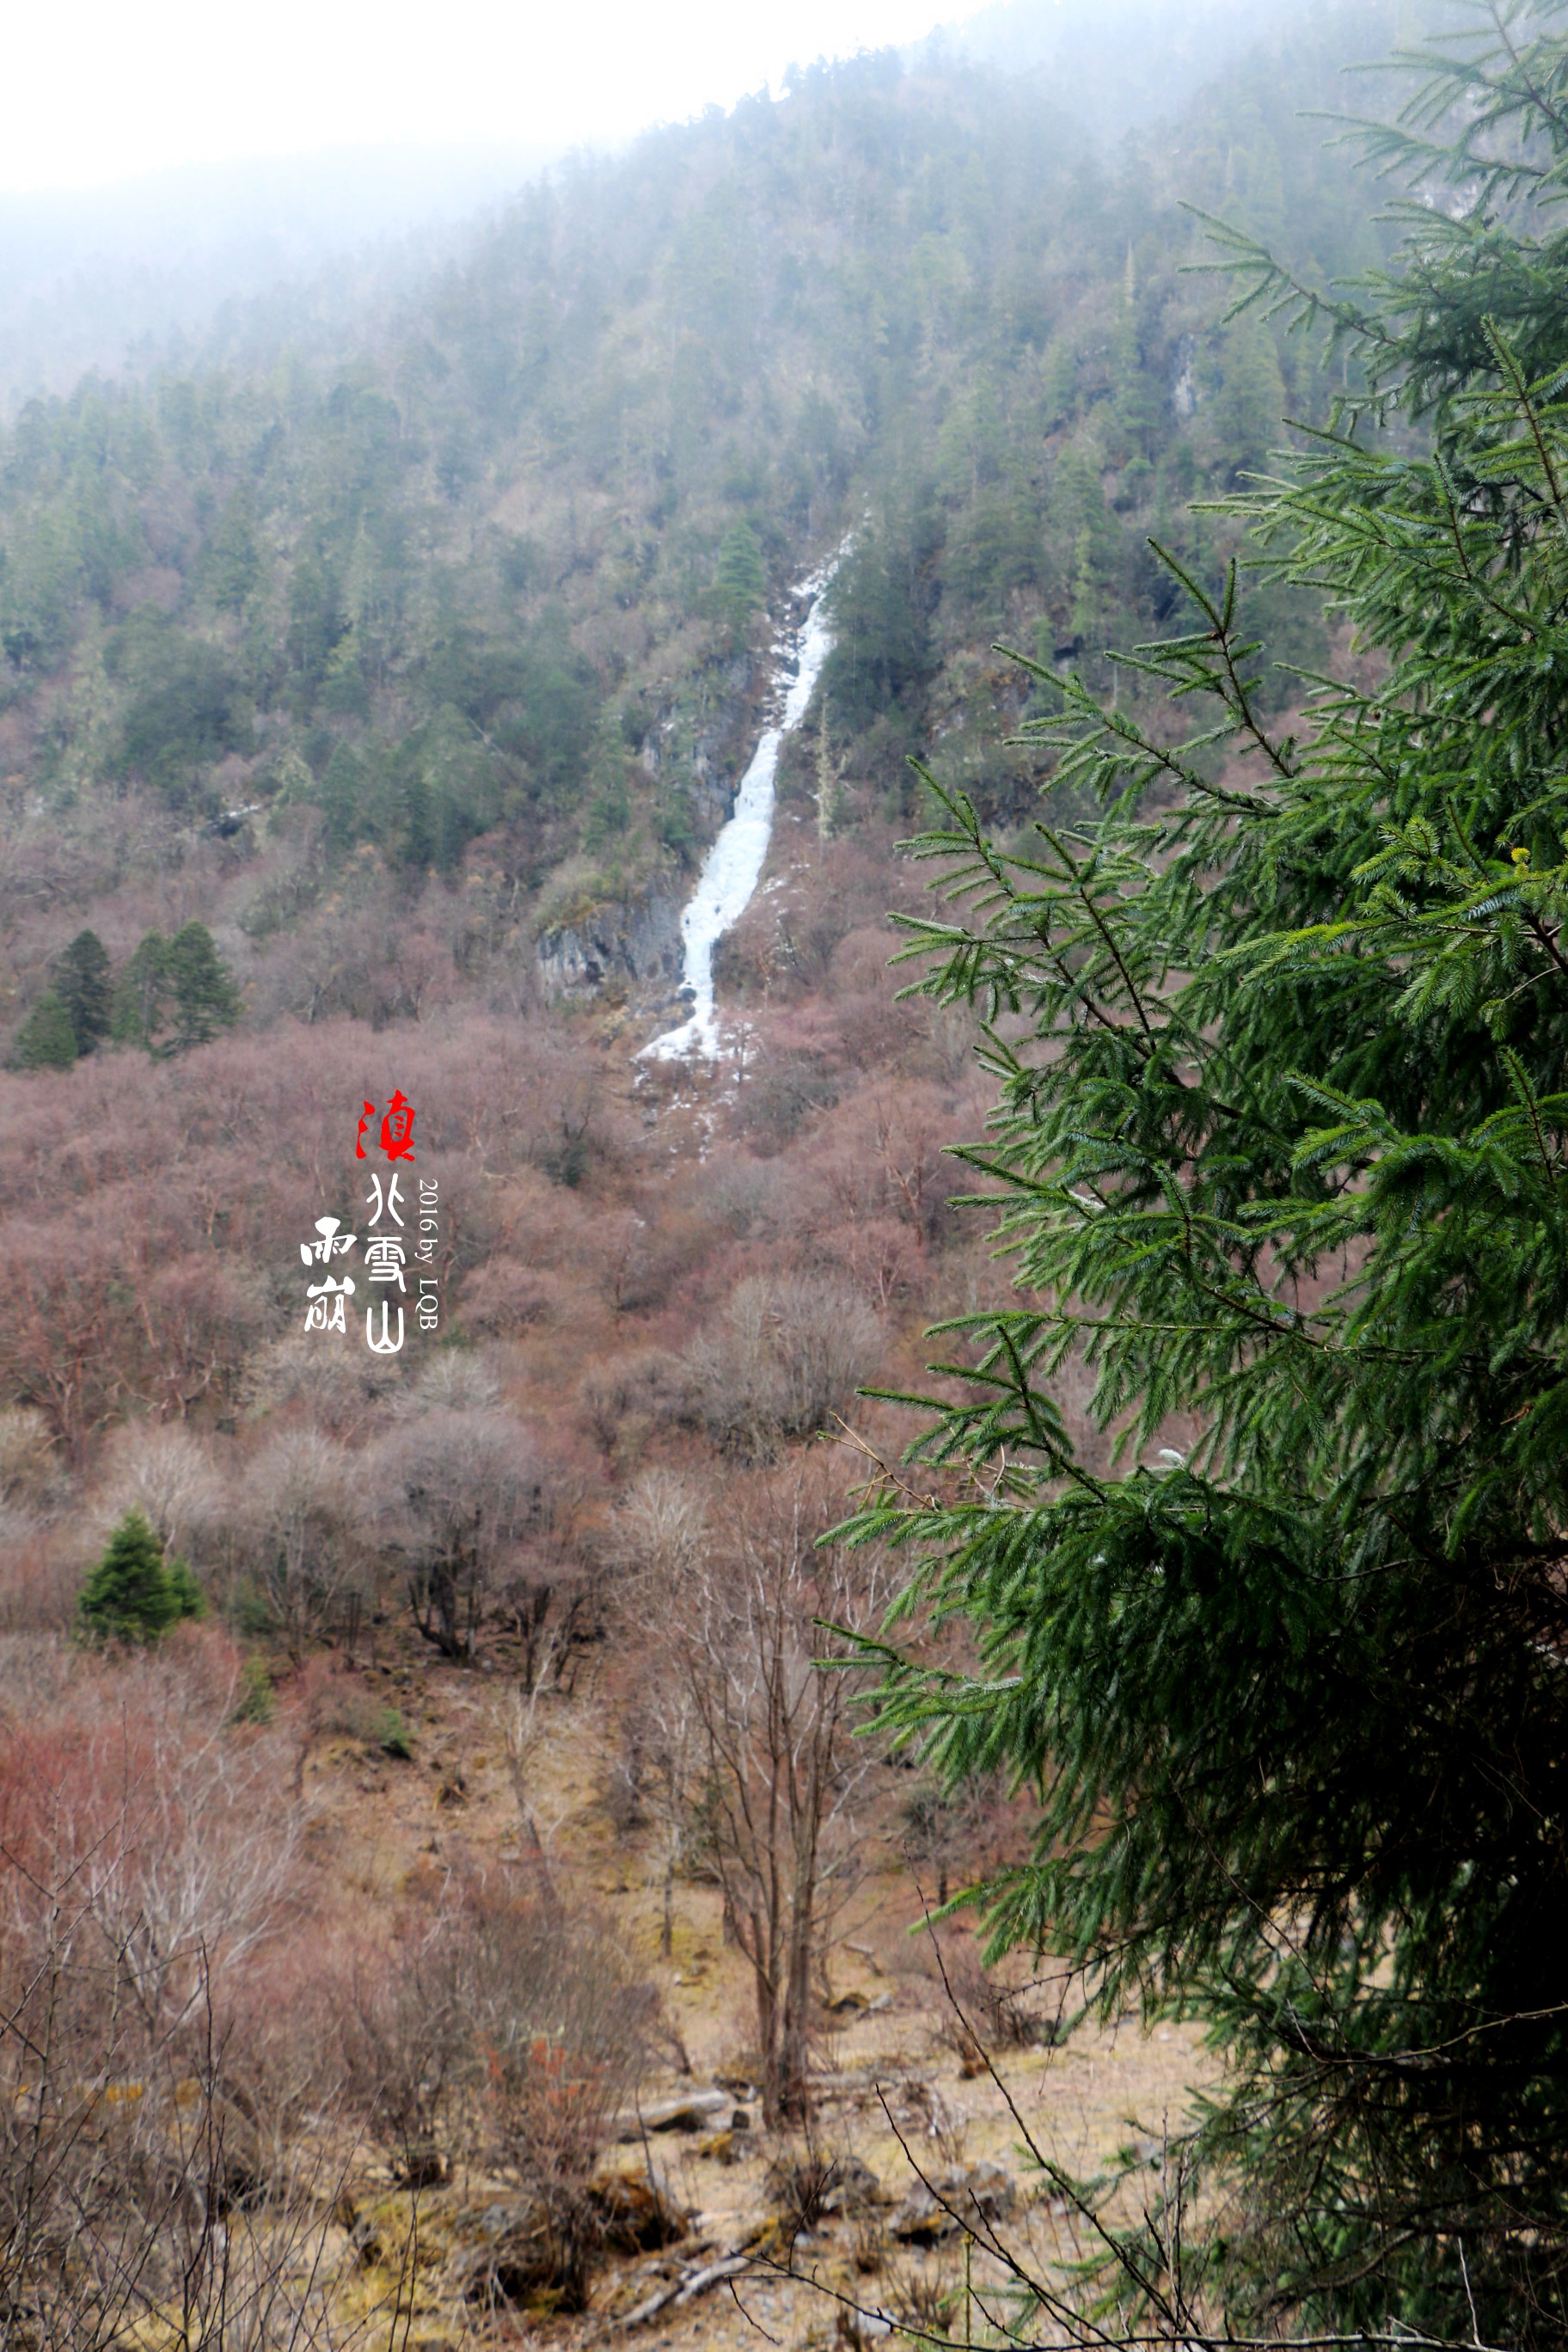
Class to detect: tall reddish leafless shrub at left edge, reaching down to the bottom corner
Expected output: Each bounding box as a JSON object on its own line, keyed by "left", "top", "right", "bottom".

{"left": 0, "top": 1693, "right": 401, "bottom": 2352}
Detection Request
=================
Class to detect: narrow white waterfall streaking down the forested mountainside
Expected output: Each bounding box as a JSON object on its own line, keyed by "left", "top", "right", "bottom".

{"left": 637, "top": 555, "right": 837, "bottom": 1061}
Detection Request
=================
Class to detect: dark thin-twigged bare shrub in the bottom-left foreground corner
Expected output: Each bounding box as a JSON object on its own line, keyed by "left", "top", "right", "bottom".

{"left": 0, "top": 1882, "right": 385, "bottom": 2352}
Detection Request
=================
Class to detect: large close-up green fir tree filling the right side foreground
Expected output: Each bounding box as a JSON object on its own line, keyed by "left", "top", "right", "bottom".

{"left": 858, "top": 0, "right": 1568, "bottom": 2345}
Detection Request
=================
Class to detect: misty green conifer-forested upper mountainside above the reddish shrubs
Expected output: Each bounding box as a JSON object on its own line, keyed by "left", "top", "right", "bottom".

{"left": 0, "top": 9, "right": 1380, "bottom": 1049}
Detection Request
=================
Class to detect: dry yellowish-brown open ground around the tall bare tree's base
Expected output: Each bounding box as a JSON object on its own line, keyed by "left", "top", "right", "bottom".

{"left": 303, "top": 1630, "right": 1213, "bottom": 2352}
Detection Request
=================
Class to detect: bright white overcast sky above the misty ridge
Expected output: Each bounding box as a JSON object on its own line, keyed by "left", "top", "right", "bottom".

{"left": 0, "top": 0, "right": 992, "bottom": 191}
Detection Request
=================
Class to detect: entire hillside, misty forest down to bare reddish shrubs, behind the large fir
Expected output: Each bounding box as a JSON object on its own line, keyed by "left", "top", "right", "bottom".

{"left": 0, "top": 0, "right": 1485, "bottom": 2352}
